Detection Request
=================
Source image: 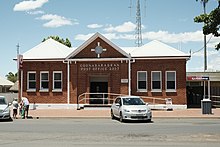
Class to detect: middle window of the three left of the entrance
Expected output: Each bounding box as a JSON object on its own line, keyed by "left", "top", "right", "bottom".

{"left": 40, "top": 71, "right": 49, "bottom": 91}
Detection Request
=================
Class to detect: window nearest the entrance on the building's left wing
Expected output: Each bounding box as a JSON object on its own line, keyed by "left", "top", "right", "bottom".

{"left": 53, "top": 71, "right": 62, "bottom": 91}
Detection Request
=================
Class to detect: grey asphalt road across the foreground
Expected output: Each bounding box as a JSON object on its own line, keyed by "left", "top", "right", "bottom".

{"left": 0, "top": 119, "right": 220, "bottom": 147}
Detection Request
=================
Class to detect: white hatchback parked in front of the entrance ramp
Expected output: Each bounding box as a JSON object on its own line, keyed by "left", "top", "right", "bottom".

{"left": 111, "top": 96, "right": 152, "bottom": 122}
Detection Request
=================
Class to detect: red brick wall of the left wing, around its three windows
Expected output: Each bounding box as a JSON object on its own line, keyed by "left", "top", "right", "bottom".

{"left": 23, "top": 61, "right": 67, "bottom": 103}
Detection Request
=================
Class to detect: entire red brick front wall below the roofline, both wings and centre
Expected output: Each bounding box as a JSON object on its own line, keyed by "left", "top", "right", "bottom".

{"left": 23, "top": 60, "right": 186, "bottom": 104}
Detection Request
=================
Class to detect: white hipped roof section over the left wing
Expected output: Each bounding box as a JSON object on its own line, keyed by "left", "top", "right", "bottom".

{"left": 23, "top": 38, "right": 73, "bottom": 60}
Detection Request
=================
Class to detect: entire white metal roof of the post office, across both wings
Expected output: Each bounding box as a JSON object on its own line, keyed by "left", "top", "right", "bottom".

{"left": 23, "top": 34, "right": 190, "bottom": 60}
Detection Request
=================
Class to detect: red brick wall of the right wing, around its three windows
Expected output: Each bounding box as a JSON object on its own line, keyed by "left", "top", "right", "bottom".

{"left": 131, "top": 59, "right": 186, "bottom": 104}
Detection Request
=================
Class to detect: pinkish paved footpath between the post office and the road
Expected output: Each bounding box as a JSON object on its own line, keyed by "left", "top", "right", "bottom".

{"left": 29, "top": 108, "right": 220, "bottom": 119}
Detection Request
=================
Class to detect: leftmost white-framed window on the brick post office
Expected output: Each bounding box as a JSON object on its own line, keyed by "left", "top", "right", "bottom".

{"left": 27, "top": 71, "right": 36, "bottom": 91}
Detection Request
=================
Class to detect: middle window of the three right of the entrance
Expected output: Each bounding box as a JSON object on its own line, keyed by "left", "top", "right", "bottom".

{"left": 151, "top": 71, "right": 162, "bottom": 92}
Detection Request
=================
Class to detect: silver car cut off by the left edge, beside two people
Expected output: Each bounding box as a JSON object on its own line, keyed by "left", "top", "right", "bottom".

{"left": 0, "top": 96, "right": 11, "bottom": 120}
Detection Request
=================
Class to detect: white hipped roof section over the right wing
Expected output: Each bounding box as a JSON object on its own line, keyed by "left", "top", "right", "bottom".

{"left": 122, "top": 40, "right": 189, "bottom": 57}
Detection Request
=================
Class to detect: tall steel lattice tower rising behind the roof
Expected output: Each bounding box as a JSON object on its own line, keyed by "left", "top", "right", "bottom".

{"left": 135, "top": 0, "right": 142, "bottom": 47}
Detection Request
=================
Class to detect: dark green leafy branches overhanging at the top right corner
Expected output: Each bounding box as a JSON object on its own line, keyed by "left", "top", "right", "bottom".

{"left": 194, "top": 0, "right": 220, "bottom": 50}
